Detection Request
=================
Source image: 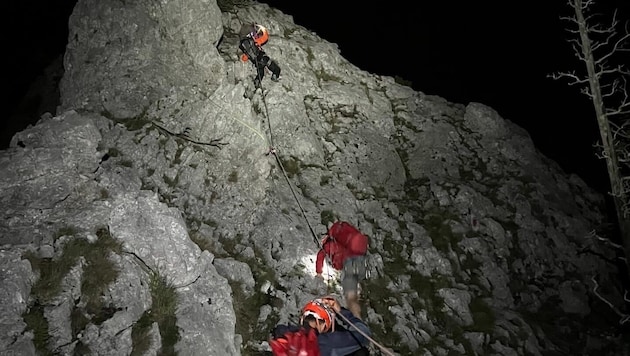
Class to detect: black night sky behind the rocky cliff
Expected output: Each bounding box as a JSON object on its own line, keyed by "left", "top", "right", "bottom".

{"left": 0, "top": 0, "right": 630, "bottom": 197}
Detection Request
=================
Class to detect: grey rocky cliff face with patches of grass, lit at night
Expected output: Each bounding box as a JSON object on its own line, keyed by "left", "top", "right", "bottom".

{"left": 0, "top": 0, "right": 628, "bottom": 355}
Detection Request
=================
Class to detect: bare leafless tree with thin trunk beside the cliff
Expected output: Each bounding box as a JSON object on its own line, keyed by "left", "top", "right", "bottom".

{"left": 551, "top": 0, "right": 630, "bottom": 273}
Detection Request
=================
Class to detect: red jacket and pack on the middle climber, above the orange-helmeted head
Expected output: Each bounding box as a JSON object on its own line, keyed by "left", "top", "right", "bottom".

{"left": 315, "top": 221, "right": 368, "bottom": 274}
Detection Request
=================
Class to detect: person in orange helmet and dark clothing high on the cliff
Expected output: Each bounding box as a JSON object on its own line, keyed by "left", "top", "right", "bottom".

{"left": 238, "top": 23, "right": 280, "bottom": 88}
